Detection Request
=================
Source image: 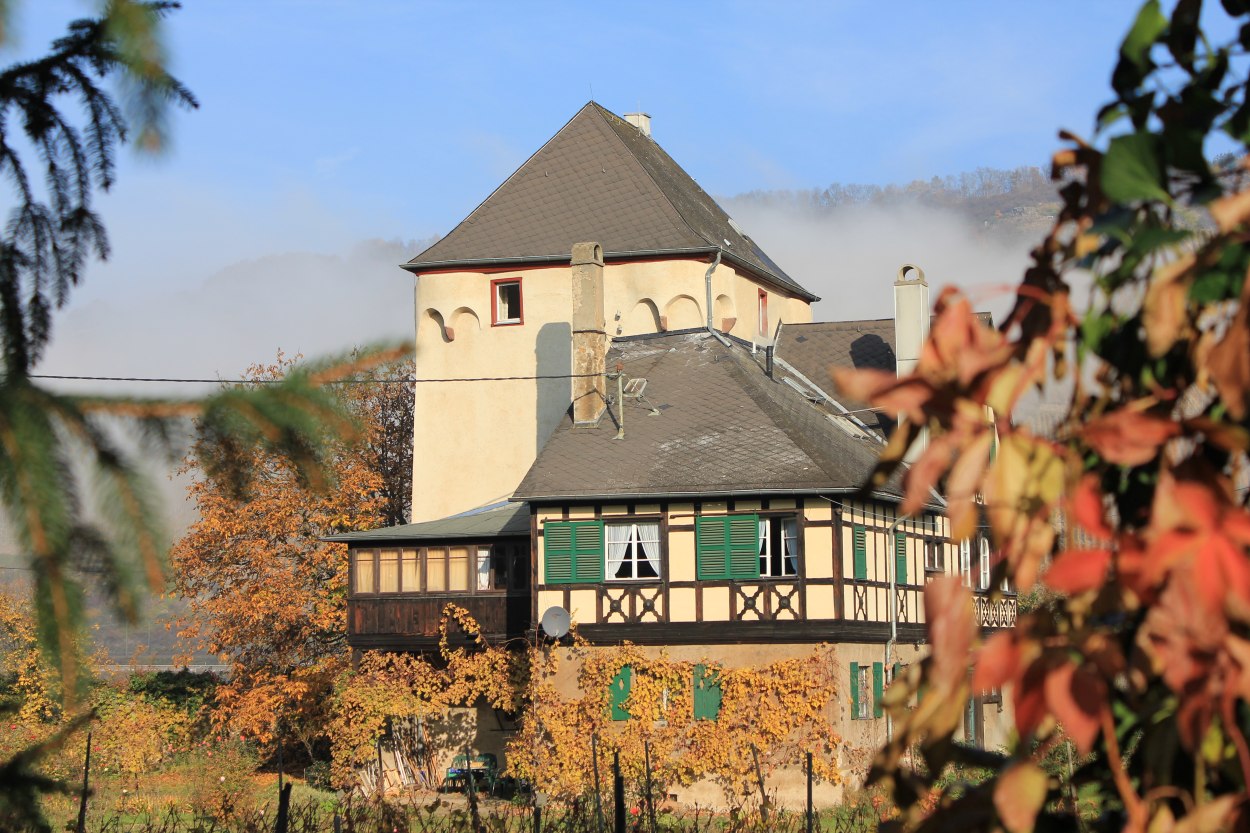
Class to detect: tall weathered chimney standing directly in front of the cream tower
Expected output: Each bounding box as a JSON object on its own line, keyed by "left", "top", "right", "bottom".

{"left": 571, "top": 243, "right": 608, "bottom": 425}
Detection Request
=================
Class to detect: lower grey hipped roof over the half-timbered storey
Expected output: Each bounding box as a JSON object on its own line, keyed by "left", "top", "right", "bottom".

{"left": 513, "top": 330, "right": 899, "bottom": 500}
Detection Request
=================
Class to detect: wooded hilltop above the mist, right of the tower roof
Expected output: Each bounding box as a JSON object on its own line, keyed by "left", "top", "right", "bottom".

{"left": 721, "top": 166, "right": 1059, "bottom": 239}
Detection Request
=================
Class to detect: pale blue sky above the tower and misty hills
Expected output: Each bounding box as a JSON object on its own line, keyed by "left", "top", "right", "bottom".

{"left": 10, "top": 0, "right": 1205, "bottom": 374}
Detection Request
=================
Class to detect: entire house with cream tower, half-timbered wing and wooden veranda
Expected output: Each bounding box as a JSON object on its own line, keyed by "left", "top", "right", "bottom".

{"left": 334, "top": 104, "right": 1015, "bottom": 802}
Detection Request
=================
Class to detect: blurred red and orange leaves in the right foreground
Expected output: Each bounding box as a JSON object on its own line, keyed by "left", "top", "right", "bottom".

{"left": 835, "top": 0, "right": 1250, "bottom": 833}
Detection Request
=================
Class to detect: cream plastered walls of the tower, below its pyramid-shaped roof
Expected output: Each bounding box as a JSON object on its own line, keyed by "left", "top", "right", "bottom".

{"left": 413, "top": 260, "right": 811, "bottom": 522}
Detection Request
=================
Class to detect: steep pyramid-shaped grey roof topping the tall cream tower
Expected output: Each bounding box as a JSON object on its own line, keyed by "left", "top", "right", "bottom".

{"left": 405, "top": 101, "right": 818, "bottom": 300}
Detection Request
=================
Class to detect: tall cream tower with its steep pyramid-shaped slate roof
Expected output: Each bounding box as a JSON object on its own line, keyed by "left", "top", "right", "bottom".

{"left": 404, "top": 103, "right": 816, "bottom": 522}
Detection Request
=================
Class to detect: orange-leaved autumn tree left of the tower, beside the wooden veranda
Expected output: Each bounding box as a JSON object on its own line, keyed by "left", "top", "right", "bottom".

{"left": 171, "top": 358, "right": 411, "bottom": 754}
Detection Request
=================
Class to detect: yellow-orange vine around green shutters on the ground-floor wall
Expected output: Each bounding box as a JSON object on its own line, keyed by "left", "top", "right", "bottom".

{"left": 508, "top": 644, "right": 840, "bottom": 802}
